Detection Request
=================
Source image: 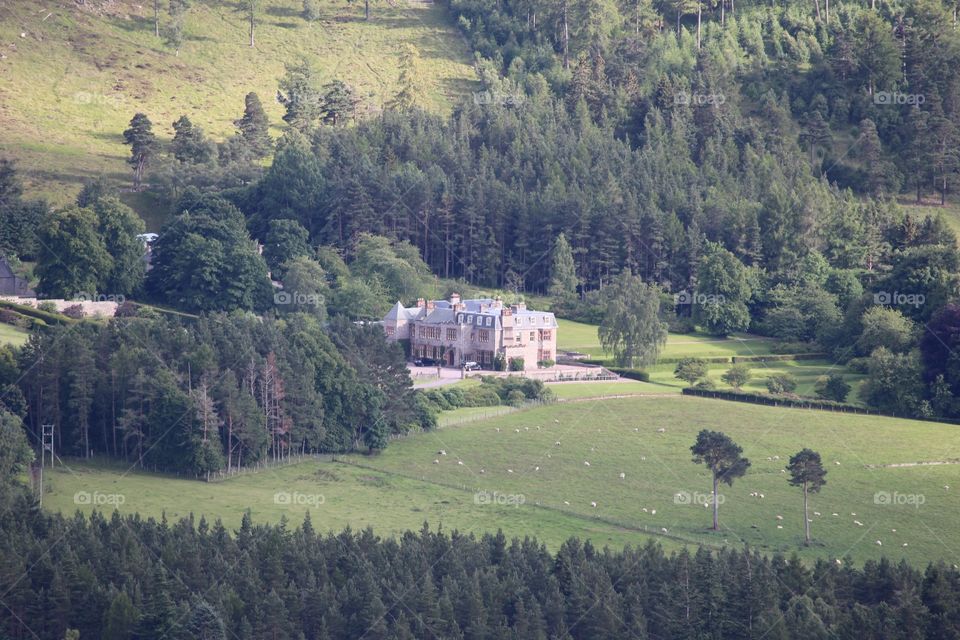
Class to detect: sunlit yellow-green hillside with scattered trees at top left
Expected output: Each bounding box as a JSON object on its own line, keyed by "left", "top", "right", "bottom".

{"left": 0, "top": 0, "right": 475, "bottom": 208}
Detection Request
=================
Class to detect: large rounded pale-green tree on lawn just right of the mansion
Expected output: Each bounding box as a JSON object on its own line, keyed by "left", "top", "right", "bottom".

{"left": 598, "top": 271, "right": 667, "bottom": 367}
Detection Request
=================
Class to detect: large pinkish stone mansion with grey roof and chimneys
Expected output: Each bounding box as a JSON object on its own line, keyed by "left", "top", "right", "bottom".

{"left": 383, "top": 294, "right": 557, "bottom": 369}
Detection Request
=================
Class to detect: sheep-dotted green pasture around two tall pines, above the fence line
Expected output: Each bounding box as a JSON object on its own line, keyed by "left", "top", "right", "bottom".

{"left": 350, "top": 396, "right": 960, "bottom": 562}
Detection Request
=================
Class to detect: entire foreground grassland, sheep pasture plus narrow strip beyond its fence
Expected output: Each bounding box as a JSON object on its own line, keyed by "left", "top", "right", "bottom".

{"left": 45, "top": 395, "right": 960, "bottom": 563}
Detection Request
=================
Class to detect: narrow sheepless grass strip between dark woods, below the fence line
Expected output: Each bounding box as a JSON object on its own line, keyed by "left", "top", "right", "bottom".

{"left": 44, "top": 458, "right": 679, "bottom": 549}
